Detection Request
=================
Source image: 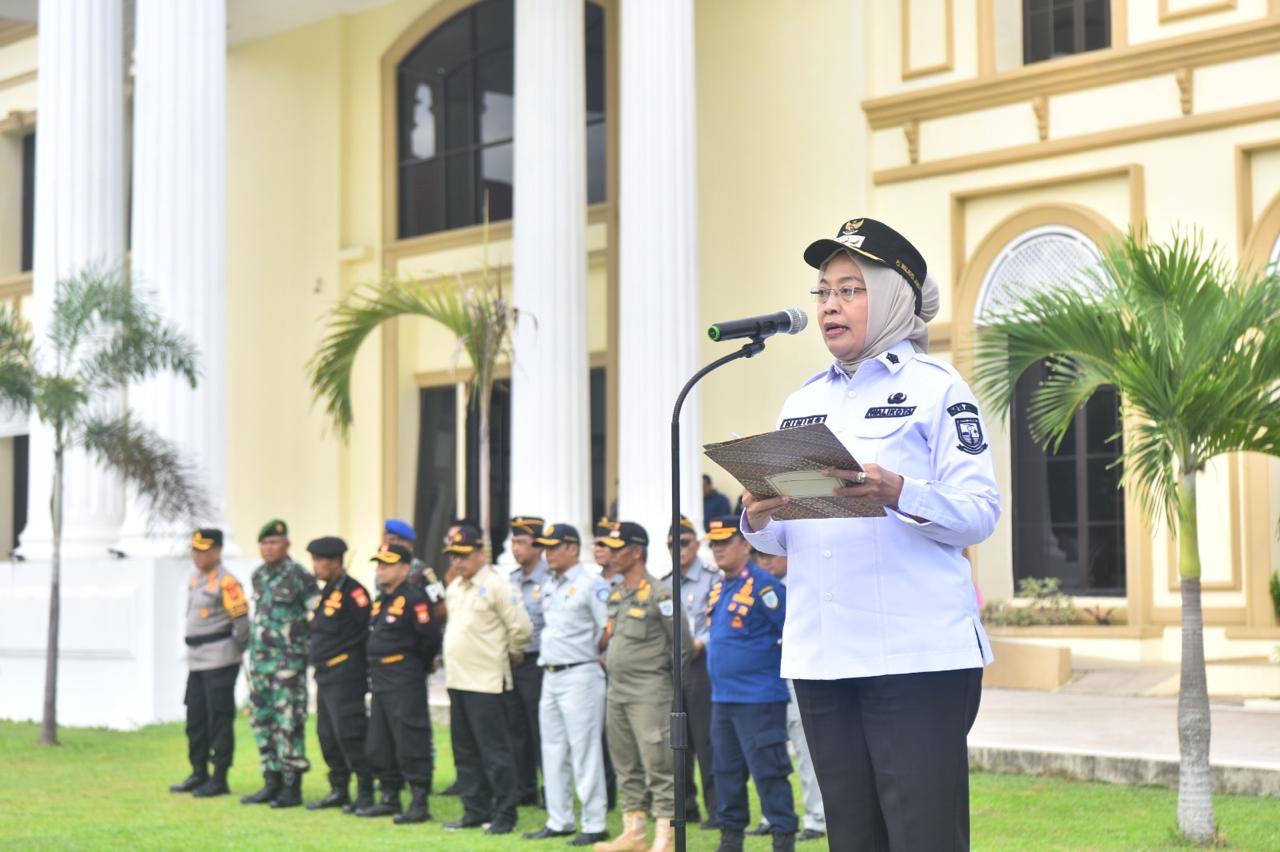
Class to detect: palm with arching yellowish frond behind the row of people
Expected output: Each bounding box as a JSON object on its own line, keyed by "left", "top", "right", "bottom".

{"left": 308, "top": 227, "right": 518, "bottom": 545}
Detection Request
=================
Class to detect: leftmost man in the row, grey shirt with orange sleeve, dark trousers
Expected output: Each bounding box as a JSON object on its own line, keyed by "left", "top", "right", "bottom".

{"left": 169, "top": 528, "right": 248, "bottom": 798}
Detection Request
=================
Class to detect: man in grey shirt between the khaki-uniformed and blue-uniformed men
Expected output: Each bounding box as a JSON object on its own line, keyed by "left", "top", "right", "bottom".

{"left": 663, "top": 516, "right": 722, "bottom": 829}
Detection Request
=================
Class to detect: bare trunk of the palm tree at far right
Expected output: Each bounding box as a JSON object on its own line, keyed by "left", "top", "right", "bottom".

{"left": 1178, "top": 473, "right": 1217, "bottom": 844}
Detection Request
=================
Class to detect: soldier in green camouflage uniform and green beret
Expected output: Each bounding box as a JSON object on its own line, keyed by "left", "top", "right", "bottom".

{"left": 241, "top": 521, "right": 320, "bottom": 807}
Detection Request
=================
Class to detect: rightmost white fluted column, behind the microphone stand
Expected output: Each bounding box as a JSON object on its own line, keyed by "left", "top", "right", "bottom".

{"left": 618, "top": 0, "right": 703, "bottom": 562}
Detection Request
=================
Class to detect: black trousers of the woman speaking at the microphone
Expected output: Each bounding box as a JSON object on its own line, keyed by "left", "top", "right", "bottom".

{"left": 795, "top": 669, "right": 982, "bottom": 852}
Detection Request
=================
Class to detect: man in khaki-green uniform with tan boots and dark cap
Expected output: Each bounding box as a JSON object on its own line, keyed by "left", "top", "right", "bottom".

{"left": 595, "top": 521, "right": 694, "bottom": 852}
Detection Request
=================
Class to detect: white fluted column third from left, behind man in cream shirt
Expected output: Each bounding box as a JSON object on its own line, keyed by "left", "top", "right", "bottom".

{"left": 511, "top": 0, "right": 591, "bottom": 535}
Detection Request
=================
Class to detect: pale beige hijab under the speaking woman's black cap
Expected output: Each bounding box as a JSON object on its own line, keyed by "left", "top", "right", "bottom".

{"left": 823, "top": 249, "right": 938, "bottom": 376}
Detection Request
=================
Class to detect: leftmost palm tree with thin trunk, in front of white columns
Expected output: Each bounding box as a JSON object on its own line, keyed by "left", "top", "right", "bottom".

{"left": 0, "top": 269, "right": 206, "bottom": 746}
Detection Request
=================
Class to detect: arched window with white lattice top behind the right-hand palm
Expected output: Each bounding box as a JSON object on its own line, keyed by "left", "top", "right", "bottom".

{"left": 978, "top": 225, "right": 1125, "bottom": 595}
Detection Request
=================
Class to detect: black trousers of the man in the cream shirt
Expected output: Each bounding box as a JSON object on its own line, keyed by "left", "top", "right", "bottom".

{"left": 449, "top": 690, "right": 520, "bottom": 825}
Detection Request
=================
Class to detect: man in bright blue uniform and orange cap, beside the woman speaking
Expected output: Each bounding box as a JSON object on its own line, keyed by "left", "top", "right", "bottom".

{"left": 707, "top": 516, "right": 797, "bottom": 852}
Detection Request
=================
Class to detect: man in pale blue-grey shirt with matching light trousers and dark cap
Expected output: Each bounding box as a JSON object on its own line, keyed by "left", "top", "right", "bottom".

{"left": 525, "top": 523, "right": 609, "bottom": 846}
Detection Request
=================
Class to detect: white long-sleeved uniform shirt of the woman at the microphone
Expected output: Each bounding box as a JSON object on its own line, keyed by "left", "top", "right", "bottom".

{"left": 742, "top": 340, "right": 1000, "bottom": 681}
